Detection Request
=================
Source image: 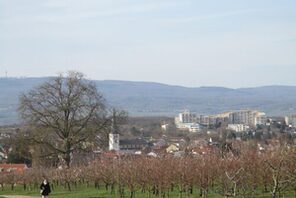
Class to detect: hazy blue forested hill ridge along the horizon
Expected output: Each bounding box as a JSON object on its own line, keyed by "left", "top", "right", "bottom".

{"left": 0, "top": 78, "right": 296, "bottom": 125}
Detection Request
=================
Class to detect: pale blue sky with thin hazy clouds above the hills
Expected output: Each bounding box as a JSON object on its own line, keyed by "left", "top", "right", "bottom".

{"left": 0, "top": 0, "right": 296, "bottom": 88}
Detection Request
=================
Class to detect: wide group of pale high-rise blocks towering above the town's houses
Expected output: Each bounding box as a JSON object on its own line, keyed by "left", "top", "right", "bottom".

{"left": 175, "top": 110, "right": 268, "bottom": 132}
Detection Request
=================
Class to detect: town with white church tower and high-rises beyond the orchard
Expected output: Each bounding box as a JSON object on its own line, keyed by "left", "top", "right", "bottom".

{"left": 0, "top": 110, "right": 296, "bottom": 165}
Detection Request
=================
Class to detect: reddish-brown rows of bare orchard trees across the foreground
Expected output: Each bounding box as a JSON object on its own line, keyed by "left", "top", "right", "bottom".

{"left": 0, "top": 147, "right": 296, "bottom": 198}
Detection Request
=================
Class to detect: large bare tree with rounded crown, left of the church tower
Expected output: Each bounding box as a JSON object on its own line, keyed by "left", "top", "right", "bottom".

{"left": 19, "top": 72, "right": 108, "bottom": 167}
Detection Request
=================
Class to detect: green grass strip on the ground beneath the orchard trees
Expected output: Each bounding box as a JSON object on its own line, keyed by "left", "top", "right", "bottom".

{"left": 0, "top": 185, "right": 294, "bottom": 198}
